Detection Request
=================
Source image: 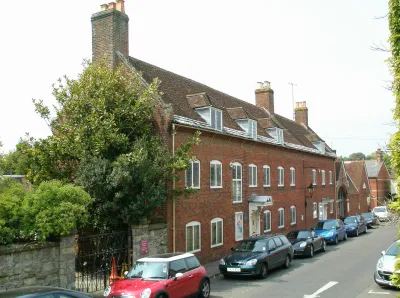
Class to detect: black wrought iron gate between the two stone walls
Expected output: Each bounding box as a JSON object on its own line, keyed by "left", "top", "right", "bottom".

{"left": 75, "top": 232, "right": 132, "bottom": 293}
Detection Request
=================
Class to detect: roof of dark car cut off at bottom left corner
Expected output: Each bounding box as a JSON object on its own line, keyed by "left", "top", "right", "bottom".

{"left": 0, "top": 286, "right": 97, "bottom": 298}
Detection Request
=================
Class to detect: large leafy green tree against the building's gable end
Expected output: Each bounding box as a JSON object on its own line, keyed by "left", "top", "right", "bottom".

{"left": 25, "top": 61, "right": 199, "bottom": 227}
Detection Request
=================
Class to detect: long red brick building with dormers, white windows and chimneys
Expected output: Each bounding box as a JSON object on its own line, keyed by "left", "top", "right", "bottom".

{"left": 92, "top": 1, "right": 336, "bottom": 262}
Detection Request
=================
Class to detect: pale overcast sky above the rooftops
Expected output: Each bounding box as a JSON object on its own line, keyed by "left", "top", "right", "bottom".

{"left": 0, "top": 0, "right": 396, "bottom": 156}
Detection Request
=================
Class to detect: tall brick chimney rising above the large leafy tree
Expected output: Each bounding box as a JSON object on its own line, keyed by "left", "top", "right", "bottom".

{"left": 92, "top": 0, "right": 129, "bottom": 68}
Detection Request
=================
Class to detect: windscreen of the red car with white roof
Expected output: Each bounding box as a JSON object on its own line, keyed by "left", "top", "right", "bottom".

{"left": 127, "top": 262, "right": 168, "bottom": 279}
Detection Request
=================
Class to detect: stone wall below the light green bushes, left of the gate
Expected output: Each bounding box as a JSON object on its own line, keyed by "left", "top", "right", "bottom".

{"left": 0, "top": 236, "right": 75, "bottom": 291}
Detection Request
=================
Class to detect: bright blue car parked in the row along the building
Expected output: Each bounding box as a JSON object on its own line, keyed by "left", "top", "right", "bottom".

{"left": 314, "top": 219, "right": 347, "bottom": 244}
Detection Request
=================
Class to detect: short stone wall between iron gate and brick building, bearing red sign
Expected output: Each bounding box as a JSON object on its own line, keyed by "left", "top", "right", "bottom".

{"left": 132, "top": 223, "right": 167, "bottom": 262}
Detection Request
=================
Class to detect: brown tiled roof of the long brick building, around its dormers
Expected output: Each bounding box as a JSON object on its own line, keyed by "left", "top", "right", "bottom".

{"left": 129, "top": 57, "right": 336, "bottom": 157}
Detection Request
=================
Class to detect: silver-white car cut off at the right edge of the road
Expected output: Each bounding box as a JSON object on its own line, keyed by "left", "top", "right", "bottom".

{"left": 374, "top": 240, "right": 400, "bottom": 286}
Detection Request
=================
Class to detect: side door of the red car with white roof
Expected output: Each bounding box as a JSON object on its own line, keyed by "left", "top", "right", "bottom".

{"left": 166, "top": 259, "right": 193, "bottom": 298}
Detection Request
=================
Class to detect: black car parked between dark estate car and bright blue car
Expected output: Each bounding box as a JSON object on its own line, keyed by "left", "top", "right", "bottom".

{"left": 286, "top": 230, "right": 326, "bottom": 257}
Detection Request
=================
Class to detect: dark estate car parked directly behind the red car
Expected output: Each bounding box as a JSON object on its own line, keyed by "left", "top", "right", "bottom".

{"left": 219, "top": 234, "right": 294, "bottom": 278}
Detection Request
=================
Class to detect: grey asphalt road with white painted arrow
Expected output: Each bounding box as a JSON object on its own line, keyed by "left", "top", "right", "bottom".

{"left": 211, "top": 226, "right": 400, "bottom": 298}
